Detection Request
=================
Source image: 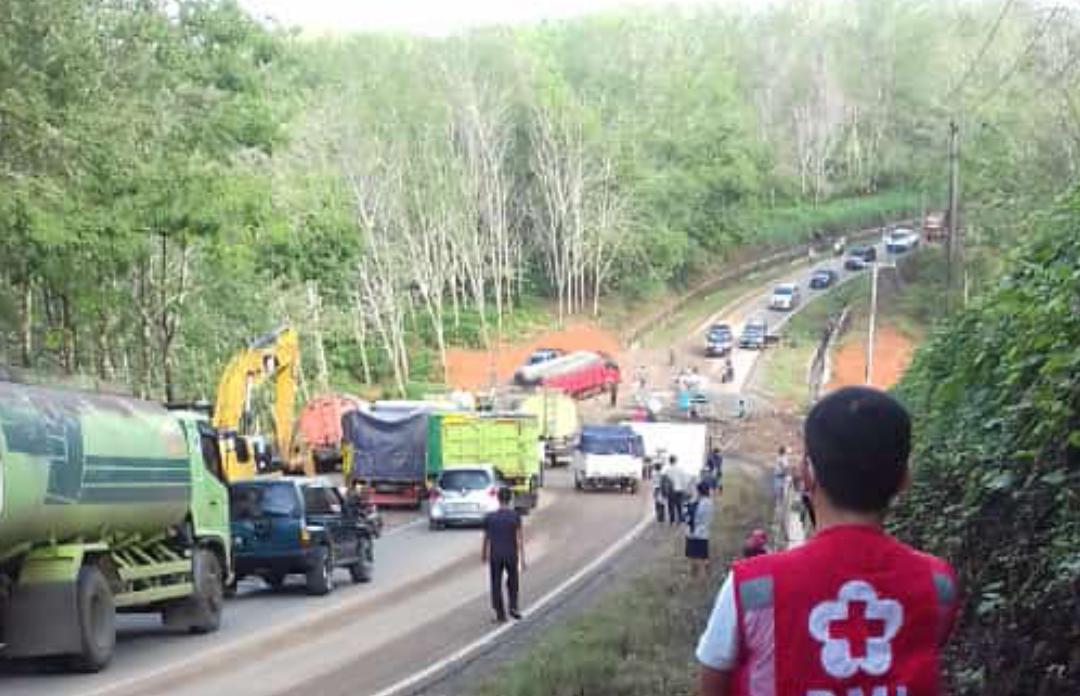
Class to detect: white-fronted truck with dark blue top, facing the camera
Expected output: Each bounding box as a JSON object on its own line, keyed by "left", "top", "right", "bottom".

{"left": 571, "top": 426, "right": 645, "bottom": 493}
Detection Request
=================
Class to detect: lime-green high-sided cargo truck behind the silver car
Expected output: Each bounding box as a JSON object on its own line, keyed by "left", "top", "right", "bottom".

{"left": 428, "top": 413, "right": 543, "bottom": 510}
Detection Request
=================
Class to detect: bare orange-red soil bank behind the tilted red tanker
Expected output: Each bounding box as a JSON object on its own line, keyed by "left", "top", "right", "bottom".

{"left": 446, "top": 323, "right": 622, "bottom": 390}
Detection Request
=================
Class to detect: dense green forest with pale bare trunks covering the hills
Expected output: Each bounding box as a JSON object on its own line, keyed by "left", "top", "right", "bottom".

{"left": 0, "top": 0, "right": 1080, "bottom": 398}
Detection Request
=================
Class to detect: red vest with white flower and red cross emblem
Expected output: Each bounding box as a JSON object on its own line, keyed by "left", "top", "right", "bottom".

{"left": 733, "top": 525, "right": 957, "bottom": 696}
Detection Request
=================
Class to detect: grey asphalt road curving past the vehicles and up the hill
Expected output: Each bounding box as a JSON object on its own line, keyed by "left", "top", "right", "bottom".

{"left": 0, "top": 233, "right": 911, "bottom": 696}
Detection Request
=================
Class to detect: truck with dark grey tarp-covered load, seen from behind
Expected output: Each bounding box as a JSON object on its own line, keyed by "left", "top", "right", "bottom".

{"left": 341, "top": 409, "right": 430, "bottom": 508}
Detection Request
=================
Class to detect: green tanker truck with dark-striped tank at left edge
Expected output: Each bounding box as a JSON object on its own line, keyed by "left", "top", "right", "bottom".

{"left": 0, "top": 382, "right": 231, "bottom": 671}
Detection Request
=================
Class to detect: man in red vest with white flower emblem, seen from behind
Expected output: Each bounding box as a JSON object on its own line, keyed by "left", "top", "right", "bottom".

{"left": 697, "top": 387, "right": 957, "bottom": 696}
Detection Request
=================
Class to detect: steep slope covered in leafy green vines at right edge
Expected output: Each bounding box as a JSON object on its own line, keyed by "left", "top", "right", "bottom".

{"left": 895, "top": 193, "right": 1080, "bottom": 696}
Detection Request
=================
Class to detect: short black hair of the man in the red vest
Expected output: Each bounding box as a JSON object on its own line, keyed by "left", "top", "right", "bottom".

{"left": 805, "top": 387, "right": 912, "bottom": 512}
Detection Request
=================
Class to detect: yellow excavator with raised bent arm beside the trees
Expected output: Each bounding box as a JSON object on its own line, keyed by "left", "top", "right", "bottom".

{"left": 213, "top": 326, "right": 300, "bottom": 482}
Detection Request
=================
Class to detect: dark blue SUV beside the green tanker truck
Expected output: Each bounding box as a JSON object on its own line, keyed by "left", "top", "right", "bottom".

{"left": 229, "top": 479, "right": 376, "bottom": 594}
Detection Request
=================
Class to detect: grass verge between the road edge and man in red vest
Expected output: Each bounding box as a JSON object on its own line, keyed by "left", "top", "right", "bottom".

{"left": 475, "top": 463, "right": 768, "bottom": 696}
